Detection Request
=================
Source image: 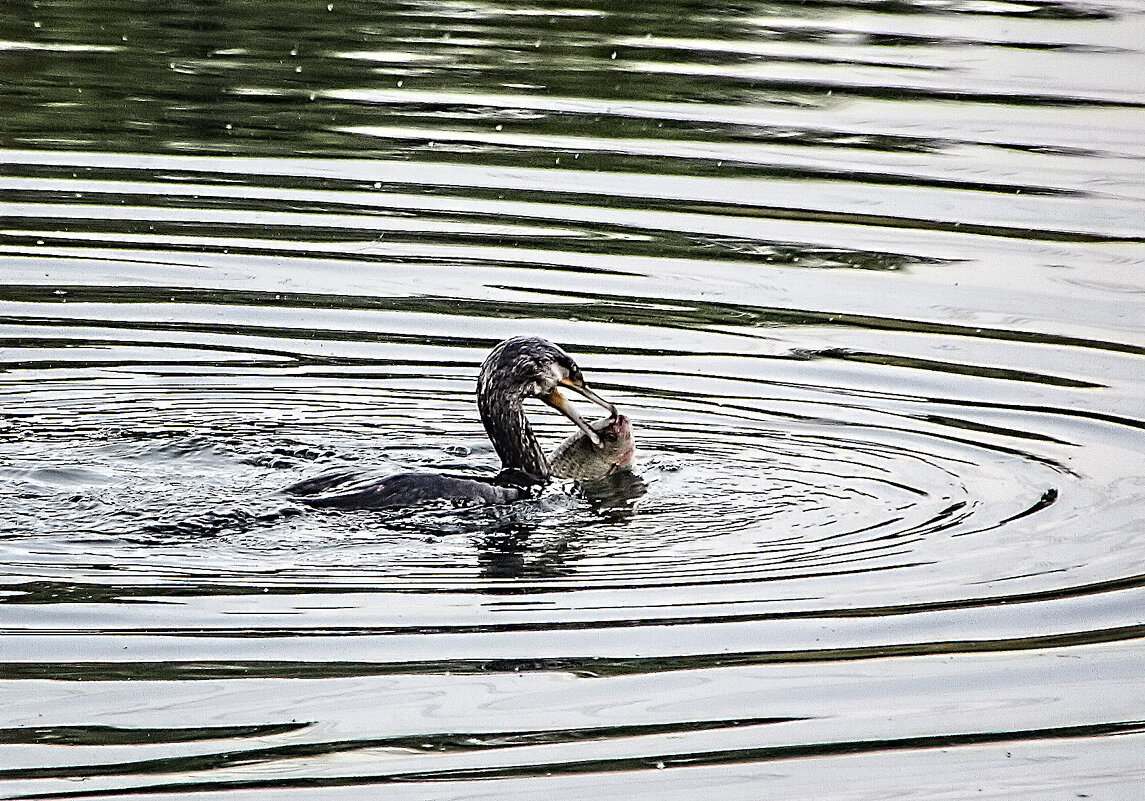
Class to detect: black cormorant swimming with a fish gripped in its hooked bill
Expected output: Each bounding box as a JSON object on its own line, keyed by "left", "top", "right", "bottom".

{"left": 283, "top": 336, "right": 617, "bottom": 509}
